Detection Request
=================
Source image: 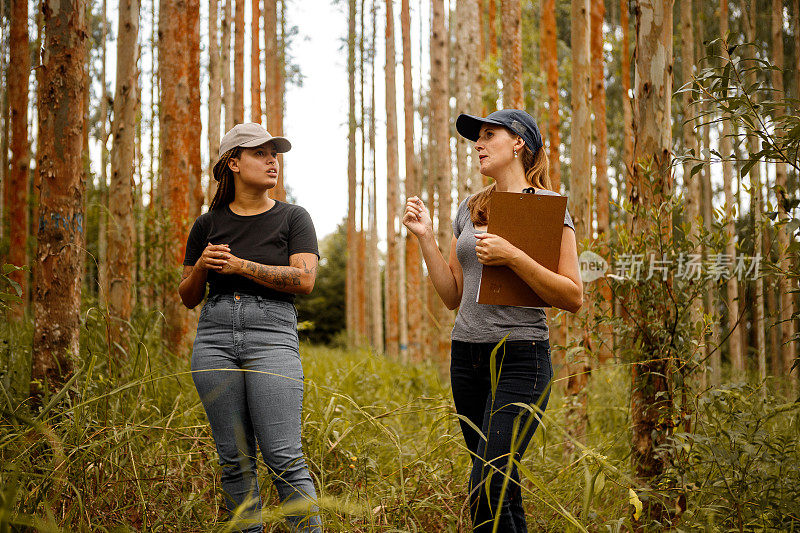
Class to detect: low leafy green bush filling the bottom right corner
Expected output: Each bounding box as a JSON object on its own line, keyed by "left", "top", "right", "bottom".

{"left": 663, "top": 385, "right": 800, "bottom": 531}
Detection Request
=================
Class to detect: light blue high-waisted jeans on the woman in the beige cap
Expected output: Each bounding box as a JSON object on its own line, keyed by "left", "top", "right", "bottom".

{"left": 192, "top": 293, "right": 321, "bottom": 532}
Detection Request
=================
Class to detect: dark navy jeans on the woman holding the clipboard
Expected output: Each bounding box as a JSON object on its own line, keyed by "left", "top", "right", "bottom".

{"left": 450, "top": 340, "right": 553, "bottom": 533}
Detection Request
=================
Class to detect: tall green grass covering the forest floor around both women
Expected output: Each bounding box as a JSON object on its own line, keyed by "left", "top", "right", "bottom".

{"left": 0, "top": 308, "right": 800, "bottom": 532}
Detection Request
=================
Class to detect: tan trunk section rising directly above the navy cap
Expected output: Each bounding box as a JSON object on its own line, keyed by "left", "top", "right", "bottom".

{"left": 500, "top": 0, "right": 525, "bottom": 109}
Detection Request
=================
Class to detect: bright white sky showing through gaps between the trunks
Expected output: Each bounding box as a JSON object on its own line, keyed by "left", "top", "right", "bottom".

{"left": 73, "top": 0, "right": 766, "bottom": 244}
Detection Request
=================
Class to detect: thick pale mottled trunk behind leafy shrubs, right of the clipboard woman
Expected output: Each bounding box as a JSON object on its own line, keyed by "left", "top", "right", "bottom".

{"left": 629, "top": 0, "right": 672, "bottom": 520}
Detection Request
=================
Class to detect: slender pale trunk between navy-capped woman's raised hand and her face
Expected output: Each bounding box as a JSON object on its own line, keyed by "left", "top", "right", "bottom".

{"left": 430, "top": 0, "right": 452, "bottom": 363}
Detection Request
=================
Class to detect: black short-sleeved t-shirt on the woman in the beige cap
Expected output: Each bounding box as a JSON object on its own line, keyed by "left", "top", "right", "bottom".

{"left": 183, "top": 200, "right": 319, "bottom": 302}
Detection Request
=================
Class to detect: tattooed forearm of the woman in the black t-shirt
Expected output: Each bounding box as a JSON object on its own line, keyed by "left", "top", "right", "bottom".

{"left": 222, "top": 253, "right": 317, "bottom": 294}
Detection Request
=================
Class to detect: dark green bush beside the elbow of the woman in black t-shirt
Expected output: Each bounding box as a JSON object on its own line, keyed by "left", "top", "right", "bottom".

{"left": 296, "top": 224, "right": 347, "bottom": 344}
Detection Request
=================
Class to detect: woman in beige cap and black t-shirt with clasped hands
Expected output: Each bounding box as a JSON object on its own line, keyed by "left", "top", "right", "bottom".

{"left": 178, "top": 123, "right": 321, "bottom": 532}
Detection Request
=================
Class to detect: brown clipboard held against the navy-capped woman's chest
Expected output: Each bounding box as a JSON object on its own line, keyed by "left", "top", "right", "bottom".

{"left": 477, "top": 191, "right": 567, "bottom": 307}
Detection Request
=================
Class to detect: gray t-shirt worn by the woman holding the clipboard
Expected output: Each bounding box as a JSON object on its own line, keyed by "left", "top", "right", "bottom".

{"left": 451, "top": 189, "right": 575, "bottom": 342}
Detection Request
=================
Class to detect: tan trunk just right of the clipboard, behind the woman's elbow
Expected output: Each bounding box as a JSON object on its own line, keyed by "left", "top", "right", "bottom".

{"left": 565, "top": 0, "right": 592, "bottom": 455}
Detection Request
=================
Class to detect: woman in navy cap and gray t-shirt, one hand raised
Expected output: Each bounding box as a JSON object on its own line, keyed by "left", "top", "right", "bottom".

{"left": 403, "top": 109, "right": 583, "bottom": 532}
